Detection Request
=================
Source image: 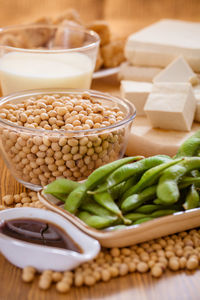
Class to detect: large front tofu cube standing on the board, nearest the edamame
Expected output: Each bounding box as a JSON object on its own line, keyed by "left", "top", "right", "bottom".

{"left": 144, "top": 82, "right": 196, "bottom": 131}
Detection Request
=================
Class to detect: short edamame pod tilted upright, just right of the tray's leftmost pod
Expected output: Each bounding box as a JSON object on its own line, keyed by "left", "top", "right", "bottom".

{"left": 64, "top": 183, "right": 87, "bottom": 214}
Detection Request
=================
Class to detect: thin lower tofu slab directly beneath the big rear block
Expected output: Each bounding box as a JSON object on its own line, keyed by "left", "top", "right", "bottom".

{"left": 118, "top": 62, "right": 162, "bottom": 82}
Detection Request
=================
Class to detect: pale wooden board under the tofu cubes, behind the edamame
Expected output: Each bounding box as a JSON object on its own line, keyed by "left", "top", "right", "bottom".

{"left": 126, "top": 117, "right": 200, "bottom": 156}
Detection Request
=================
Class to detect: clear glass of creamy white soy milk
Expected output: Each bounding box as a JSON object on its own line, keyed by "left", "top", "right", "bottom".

{"left": 0, "top": 24, "right": 99, "bottom": 95}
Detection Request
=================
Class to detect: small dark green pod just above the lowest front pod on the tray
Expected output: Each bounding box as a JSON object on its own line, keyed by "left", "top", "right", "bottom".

{"left": 80, "top": 199, "right": 117, "bottom": 220}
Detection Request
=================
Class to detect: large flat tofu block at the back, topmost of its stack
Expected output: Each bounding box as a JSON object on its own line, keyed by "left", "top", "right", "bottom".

{"left": 125, "top": 19, "right": 200, "bottom": 72}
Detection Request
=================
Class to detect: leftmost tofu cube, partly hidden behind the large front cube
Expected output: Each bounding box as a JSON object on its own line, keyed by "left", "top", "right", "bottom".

{"left": 120, "top": 80, "right": 152, "bottom": 116}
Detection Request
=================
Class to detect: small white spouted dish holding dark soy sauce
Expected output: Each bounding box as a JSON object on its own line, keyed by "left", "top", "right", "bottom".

{"left": 0, "top": 207, "right": 100, "bottom": 271}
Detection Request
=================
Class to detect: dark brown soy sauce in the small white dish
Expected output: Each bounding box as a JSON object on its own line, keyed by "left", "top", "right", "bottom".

{"left": 0, "top": 219, "right": 83, "bottom": 253}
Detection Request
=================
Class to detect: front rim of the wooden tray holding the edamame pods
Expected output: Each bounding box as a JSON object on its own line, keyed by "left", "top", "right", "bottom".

{"left": 38, "top": 191, "right": 200, "bottom": 248}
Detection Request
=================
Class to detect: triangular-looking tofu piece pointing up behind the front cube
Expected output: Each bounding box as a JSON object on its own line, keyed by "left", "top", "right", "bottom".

{"left": 153, "top": 56, "right": 197, "bottom": 82}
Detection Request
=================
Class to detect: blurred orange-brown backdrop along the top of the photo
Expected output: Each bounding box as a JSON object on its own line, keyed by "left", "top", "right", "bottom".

{"left": 0, "top": 0, "right": 200, "bottom": 37}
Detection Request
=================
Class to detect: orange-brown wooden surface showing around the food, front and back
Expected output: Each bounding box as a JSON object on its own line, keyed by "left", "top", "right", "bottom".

{"left": 0, "top": 0, "right": 200, "bottom": 300}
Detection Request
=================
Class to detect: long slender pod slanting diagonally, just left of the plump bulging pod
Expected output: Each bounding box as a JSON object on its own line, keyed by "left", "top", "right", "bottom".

{"left": 123, "top": 158, "right": 182, "bottom": 199}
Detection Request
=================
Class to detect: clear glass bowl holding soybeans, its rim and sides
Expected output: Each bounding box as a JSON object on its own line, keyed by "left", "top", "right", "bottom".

{"left": 0, "top": 89, "right": 136, "bottom": 191}
